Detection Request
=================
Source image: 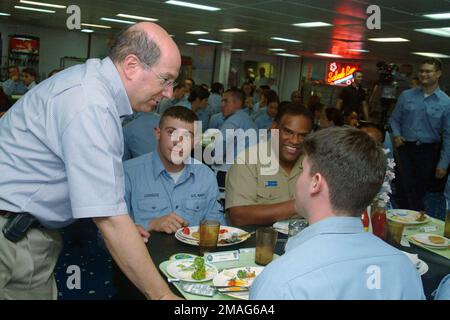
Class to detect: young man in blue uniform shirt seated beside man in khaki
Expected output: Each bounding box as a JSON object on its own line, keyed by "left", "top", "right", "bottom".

{"left": 124, "top": 106, "right": 225, "bottom": 233}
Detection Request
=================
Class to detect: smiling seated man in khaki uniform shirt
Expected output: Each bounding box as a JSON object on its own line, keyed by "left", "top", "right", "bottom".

{"left": 225, "top": 103, "right": 313, "bottom": 226}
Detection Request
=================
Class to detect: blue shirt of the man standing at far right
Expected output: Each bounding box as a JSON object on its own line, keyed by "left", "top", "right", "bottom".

{"left": 390, "top": 87, "right": 450, "bottom": 169}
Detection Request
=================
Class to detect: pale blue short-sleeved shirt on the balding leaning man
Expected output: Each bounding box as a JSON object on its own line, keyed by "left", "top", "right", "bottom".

{"left": 0, "top": 58, "right": 132, "bottom": 228}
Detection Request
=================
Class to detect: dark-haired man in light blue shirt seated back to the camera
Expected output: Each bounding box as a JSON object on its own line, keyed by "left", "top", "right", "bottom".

{"left": 250, "top": 128, "right": 424, "bottom": 300}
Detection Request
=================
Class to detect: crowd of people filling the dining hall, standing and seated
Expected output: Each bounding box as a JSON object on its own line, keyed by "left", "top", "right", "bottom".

{"left": 0, "top": 22, "right": 450, "bottom": 299}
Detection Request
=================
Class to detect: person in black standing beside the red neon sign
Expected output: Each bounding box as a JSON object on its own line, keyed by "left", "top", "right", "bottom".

{"left": 336, "top": 70, "right": 369, "bottom": 120}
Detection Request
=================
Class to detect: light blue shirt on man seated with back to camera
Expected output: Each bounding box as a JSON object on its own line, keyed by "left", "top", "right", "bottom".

{"left": 250, "top": 217, "right": 425, "bottom": 300}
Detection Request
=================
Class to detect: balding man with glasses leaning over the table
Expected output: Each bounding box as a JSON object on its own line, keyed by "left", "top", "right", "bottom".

{"left": 0, "top": 22, "right": 181, "bottom": 299}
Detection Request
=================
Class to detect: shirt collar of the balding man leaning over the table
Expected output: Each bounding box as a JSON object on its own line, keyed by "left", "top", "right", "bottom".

{"left": 100, "top": 57, "right": 133, "bottom": 116}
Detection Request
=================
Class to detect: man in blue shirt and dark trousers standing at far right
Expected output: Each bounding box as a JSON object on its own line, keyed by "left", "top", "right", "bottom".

{"left": 390, "top": 58, "right": 450, "bottom": 210}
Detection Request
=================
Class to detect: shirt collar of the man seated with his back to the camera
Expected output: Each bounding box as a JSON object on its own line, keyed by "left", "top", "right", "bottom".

{"left": 286, "top": 217, "right": 365, "bottom": 252}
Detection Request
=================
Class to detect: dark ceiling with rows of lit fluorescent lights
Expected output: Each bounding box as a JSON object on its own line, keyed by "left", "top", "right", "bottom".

{"left": 0, "top": 0, "right": 450, "bottom": 61}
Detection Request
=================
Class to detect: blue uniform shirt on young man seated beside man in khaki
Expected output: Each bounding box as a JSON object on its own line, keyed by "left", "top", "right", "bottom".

{"left": 124, "top": 151, "right": 225, "bottom": 229}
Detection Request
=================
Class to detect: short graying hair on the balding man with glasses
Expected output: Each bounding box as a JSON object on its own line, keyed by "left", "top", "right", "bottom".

{"left": 109, "top": 28, "right": 161, "bottom": 67}
